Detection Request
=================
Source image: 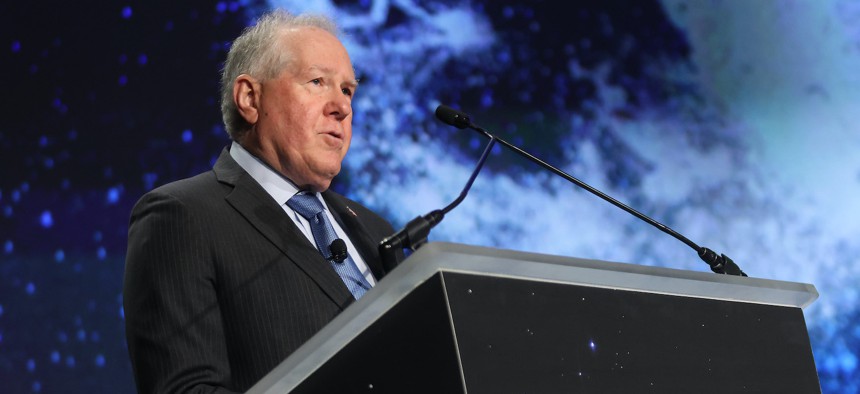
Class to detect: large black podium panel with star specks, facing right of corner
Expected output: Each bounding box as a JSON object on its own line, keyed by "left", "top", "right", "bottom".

{"left": 443, "top": 273, "right": 820, "bottom": 393}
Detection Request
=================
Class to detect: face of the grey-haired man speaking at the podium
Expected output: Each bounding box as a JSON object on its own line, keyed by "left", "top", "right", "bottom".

{"left": 249, "top": 28, "right": 357, "bottom": 191}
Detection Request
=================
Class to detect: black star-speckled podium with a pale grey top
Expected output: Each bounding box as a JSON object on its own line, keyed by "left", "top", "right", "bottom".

{"left": 249, "top": 243, "right": 821, "bottom": 394}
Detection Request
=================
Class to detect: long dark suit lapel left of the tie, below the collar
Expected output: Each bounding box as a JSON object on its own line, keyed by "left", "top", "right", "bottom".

{"left": 214, "top": 149, "right": 354, "bottom": 308}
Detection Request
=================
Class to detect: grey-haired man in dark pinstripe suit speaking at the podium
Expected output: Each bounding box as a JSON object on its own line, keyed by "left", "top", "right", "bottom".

{"left": 123, "top": 11, "right": 404, "bottom": 393}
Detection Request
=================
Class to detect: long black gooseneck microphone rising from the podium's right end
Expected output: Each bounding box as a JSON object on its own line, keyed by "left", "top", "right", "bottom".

{"left": 436, "top": 104, "right": 747, "bottom": 276}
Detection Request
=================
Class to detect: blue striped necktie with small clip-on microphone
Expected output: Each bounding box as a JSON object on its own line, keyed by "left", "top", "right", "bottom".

{"left": 287, "top": 192, "right": 370, "bottom": 299}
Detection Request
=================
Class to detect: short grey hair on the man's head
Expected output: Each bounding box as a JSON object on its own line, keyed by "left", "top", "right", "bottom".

{"left": 221, "top": 9, "right": 340, "bottom": 141}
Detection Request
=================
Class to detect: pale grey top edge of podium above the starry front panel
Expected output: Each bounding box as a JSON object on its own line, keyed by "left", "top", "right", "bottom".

{"left": 404, "top": 242, "right": 818, "bottom": 308}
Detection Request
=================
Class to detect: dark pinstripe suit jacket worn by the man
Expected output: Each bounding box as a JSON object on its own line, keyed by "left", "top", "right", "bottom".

{"left": 123, "top": 149, "right": 404, "bottom": 393}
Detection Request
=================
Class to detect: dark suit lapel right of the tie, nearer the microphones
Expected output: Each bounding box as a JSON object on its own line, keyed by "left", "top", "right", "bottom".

{"left": 322, "top": 190, "right": 385, "bottom": 279}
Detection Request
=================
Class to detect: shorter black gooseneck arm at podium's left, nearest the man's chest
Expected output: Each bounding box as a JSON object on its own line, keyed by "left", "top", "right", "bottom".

{"left": 378, "top": 136, "right": 496, "bottom": 272}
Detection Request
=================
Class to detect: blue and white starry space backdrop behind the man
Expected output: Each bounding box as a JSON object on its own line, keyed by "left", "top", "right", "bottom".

{"left": 0, "top": 0, "right": 860, "bottom": 393}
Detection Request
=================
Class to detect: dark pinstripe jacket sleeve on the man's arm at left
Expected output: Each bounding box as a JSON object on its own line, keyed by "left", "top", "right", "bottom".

{"left": 123, "top": 191, "right": 239, "bottom": 393}
